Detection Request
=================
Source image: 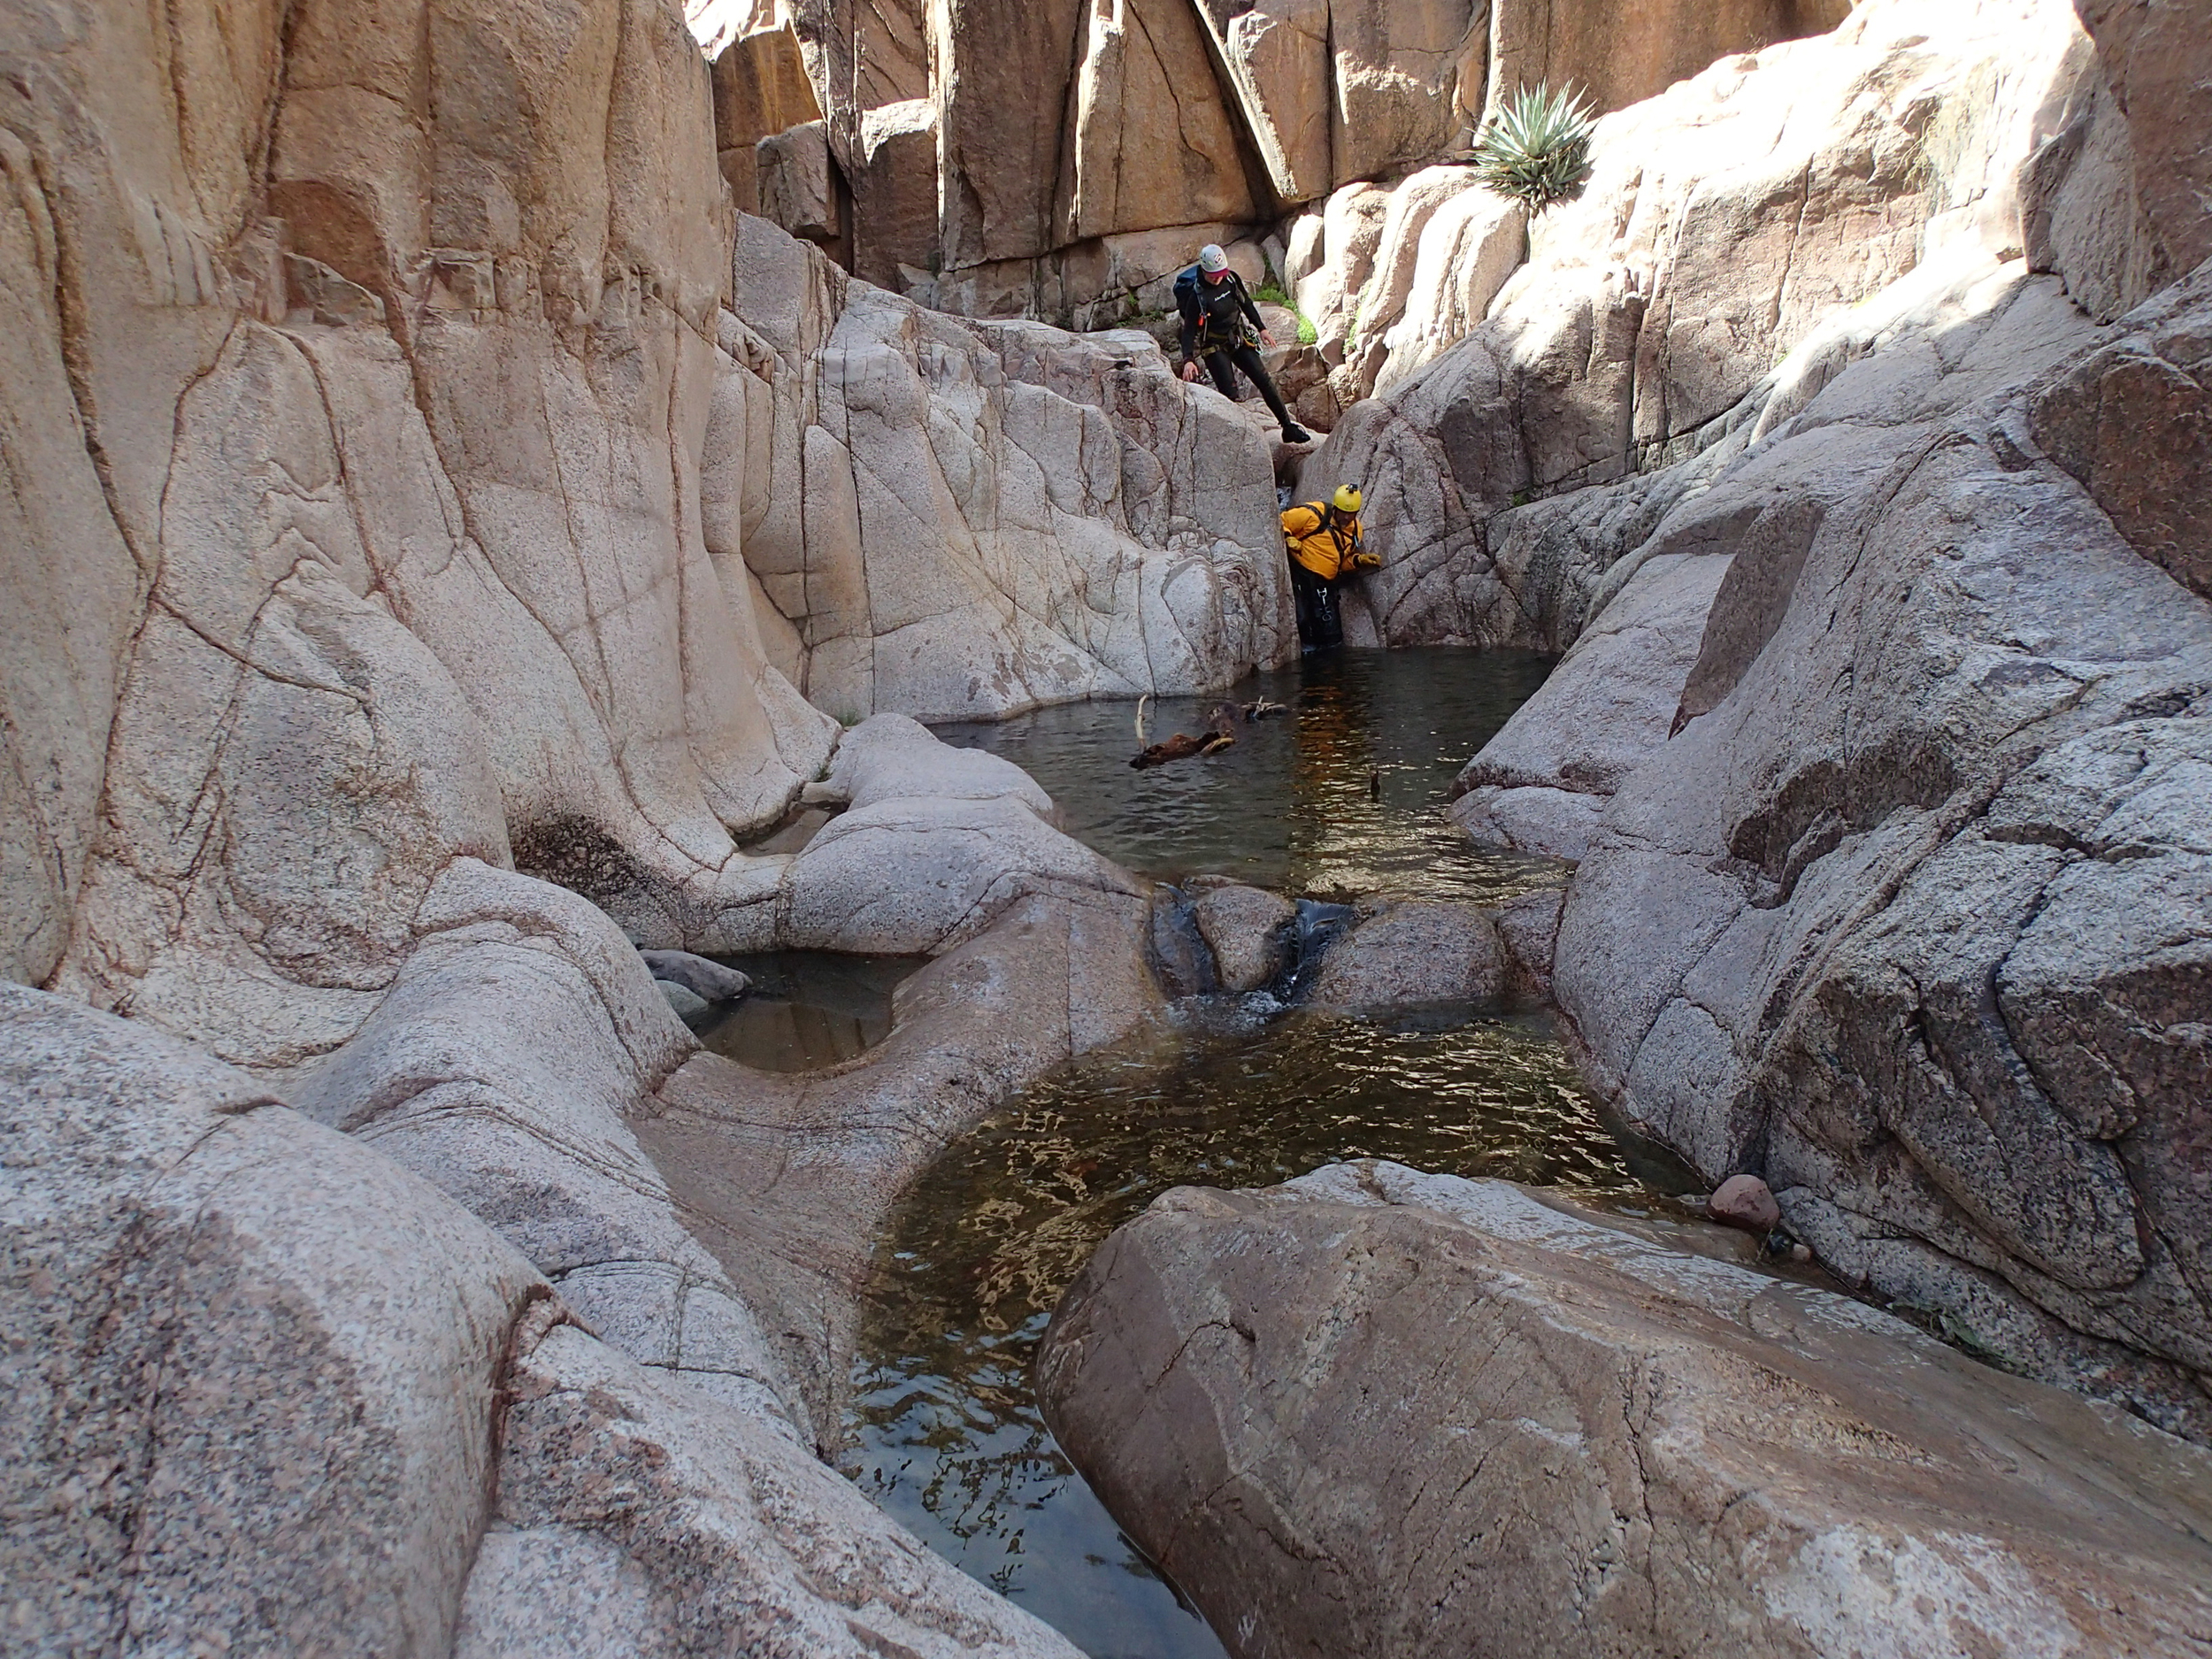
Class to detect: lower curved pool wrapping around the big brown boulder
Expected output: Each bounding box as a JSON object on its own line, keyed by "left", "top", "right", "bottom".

{"left": 848, "top": 995, "right": 1644, "bottom": 1659}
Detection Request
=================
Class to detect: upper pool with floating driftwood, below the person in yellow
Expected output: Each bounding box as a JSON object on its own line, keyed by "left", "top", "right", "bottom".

{"left": 936, "top": 646, "right": 1562, "bottom": 902}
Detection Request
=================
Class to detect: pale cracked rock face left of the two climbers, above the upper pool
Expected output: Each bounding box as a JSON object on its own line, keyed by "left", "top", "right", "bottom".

{"left": 703, "top": 219, "right": 1296, "bottom": 734}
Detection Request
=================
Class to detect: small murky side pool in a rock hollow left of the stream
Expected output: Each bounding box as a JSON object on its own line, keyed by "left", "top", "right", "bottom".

{"left": 697, "top": 951, "right": 929, "bottom": 1071}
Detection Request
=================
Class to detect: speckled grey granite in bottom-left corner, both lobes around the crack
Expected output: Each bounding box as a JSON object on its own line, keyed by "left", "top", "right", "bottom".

{"left": 0, "top": 982, "right": 1093, "bottom": 1659}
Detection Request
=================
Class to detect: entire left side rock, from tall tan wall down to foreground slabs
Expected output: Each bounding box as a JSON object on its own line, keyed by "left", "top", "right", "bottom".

{"left": 0, "top": 0, "right": 1292, "bottom": 1659}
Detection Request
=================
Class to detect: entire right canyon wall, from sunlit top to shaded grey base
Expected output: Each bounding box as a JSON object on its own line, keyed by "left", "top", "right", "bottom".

{"left": 1303, "top": 0, "right": 2212, "bottom": 1438}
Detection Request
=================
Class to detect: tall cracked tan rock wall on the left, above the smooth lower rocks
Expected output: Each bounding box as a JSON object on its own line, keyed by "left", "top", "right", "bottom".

{"left": 0, "top": 4, "right": 1290, "bottom": 987}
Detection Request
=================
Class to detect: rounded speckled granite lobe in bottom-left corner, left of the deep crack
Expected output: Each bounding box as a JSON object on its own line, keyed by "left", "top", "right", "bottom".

{"left": 0, "top": 985, "right": 544, "bottom": 1655}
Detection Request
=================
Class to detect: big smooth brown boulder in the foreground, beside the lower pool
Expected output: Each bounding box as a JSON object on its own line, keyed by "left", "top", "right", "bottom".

{"left": 1038, "top": 1164, "right": 2212, "bottom": 1659}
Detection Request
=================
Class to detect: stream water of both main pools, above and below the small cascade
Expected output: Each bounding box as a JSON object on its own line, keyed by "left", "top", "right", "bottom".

{"left": 845, "top": 649, "right": 1648, "bottom": 1659}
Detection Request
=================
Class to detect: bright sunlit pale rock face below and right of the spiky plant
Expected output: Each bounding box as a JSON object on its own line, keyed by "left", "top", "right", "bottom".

{"left": 1301, "top": 0, "right": 2110, "bottom": 650}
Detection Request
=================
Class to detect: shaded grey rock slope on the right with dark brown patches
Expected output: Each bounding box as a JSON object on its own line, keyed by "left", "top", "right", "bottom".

{"left": 1486, "top": 257, "right": 2212, "bottom": 1436}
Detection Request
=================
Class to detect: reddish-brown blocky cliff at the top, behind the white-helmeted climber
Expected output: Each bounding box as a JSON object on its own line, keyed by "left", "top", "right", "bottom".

{"left": 721, "top": 0, "right": 1849, "bottom": 327}
